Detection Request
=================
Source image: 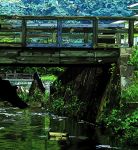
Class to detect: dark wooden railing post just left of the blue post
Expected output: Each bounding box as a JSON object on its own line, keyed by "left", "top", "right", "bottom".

{"left": 21, "top": 19, "right": 27, "bottom": 47}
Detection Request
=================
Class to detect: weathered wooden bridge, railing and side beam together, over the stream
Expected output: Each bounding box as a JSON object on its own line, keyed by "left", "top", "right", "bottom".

{"left": 0, "top": 16, "right": 138, "bottom": 65}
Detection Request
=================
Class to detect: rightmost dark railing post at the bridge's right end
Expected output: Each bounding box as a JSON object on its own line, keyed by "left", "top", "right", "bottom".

{"left": 128, "top": 20, "right": 134, "bottom": 47}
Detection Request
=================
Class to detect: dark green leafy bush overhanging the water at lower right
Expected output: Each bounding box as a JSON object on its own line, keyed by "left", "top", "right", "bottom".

{"left": 100, "top": 106, "right": 138, "bottom": 145}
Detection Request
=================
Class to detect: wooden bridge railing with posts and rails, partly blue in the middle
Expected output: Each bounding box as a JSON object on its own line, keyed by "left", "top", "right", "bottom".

{"left": 0, "top": 16, "right": 138, "bottom": 48}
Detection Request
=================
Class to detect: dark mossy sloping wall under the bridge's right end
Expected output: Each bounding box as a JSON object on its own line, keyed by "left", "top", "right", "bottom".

{"left": 96, "top": 63, "right": 121, "bottom": 122}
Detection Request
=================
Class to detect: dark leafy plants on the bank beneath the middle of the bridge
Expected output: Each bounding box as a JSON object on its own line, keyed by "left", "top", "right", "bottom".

{"left": 46, "top": 81, "right": 85, "bottom": 119}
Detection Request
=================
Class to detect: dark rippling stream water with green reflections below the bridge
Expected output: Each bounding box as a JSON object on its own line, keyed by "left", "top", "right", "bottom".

{"left": 0, "top": 107, "right": 137, "bottom": 150}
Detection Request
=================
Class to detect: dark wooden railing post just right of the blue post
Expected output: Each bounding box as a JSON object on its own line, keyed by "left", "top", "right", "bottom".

{"left": 92, "top": 17, "right": 98, "bottom": 48}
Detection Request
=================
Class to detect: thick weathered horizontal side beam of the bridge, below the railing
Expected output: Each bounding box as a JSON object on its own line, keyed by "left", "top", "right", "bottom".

{"left": 0, "top": 47, "right": 120, "bottom": 65}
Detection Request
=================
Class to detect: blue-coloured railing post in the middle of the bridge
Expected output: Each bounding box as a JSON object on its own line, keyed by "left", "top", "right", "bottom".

{"left": 57, "top": 20, "right": 62, "bottom": 47}
